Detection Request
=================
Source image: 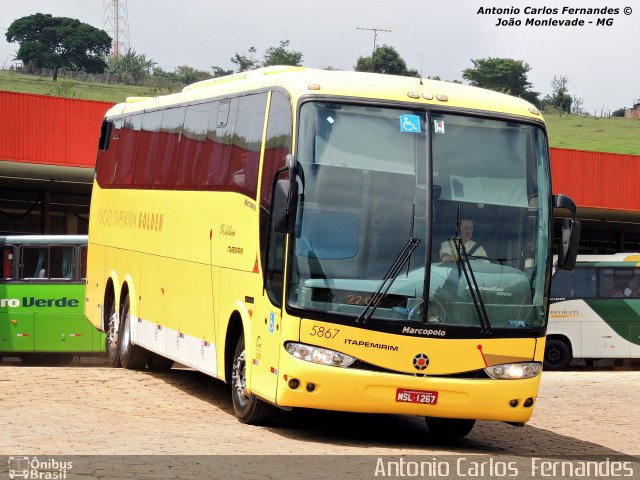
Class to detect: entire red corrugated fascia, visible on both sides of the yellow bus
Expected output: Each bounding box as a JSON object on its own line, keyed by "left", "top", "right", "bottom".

{"left": 0, "top": 91, "right": 640, "bottom": 211}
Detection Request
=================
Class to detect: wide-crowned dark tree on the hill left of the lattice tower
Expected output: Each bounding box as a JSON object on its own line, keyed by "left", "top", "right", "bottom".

{"left": 6, "top": 13, "right": 111, "bottom": 81}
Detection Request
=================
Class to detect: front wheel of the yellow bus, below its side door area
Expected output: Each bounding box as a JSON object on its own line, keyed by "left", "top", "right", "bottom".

{"left": 231, "top": 335, "right": 276, "bottom": 425}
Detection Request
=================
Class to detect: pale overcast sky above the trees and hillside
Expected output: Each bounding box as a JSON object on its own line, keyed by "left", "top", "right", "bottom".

{"left": 0, "top": 0, "right": 640, "bottom": 115}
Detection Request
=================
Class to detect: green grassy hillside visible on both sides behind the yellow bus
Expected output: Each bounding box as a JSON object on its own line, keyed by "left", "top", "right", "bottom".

{"left": 0, "top": 70, "right": 640, "bottom": 155}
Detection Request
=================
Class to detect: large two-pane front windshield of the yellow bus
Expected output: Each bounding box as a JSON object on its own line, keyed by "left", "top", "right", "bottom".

{"left": 287, "top": 102, "right": 551, "bottom": 329}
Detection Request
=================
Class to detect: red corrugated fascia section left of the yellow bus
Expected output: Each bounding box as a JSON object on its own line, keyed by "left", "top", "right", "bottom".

{"left": 0, "top": 91, "right": 113, "bottom": 168}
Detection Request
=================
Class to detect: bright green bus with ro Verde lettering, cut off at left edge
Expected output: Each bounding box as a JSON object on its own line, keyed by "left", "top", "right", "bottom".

{"left": 0, "top": 235, "right": 105, "bottom": 364}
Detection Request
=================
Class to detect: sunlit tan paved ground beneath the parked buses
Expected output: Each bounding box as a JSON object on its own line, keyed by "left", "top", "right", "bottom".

{"left": 0, "top": 361, "right": 640, "bottom": 456}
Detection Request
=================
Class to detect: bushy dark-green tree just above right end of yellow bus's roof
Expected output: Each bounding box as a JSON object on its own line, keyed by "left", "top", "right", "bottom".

{"left": 462, "top": 58, "right": 540, "bottom": 105}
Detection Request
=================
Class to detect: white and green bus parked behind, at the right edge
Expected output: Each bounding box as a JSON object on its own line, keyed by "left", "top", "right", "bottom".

{"left": 544, "top": 253, "right": 640, "bottom": 370}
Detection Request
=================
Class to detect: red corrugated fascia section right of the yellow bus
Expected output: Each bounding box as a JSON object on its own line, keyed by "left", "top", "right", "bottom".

{"left": 551, "top": 148, "right": 640, "bottom": 211}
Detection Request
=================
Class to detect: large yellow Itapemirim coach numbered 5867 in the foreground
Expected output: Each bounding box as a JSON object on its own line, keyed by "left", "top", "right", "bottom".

{"left": 85, "top": 67, "right": 579, "bottom": 437}
